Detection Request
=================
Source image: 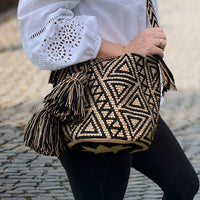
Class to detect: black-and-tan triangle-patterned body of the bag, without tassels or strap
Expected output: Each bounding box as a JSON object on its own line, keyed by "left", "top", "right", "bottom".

{"left": 60, "top": 53, "right": 161, "bottom": 154}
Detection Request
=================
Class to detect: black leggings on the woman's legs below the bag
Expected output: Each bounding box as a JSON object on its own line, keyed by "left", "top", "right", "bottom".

{"left": 59, "top": 118, "right": 199, "bottom": 200}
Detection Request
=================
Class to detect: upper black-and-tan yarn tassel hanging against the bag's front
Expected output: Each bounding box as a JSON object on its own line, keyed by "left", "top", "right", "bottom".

{"left": 44, "top": 71, "right": 87, "bottom": 123}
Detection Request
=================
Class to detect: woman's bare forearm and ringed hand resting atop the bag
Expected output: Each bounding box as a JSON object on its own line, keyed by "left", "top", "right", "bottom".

{"left": 97, "top": 28, "right": 166, "bottom": 58}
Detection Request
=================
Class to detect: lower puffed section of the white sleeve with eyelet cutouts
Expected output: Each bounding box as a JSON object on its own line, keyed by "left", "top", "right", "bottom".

{"left": 21, "top": 11, "right": 101, "bottom": 70}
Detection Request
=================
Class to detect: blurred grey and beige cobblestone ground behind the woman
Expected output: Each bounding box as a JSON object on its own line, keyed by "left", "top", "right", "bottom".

{"left": 0, "top": 0, "right": 200, "bottom": 200}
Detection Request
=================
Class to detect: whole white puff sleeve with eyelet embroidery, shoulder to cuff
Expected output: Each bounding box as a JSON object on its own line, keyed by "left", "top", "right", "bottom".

{"left": 18, "top": 0, "right": 101, "bottom": 70}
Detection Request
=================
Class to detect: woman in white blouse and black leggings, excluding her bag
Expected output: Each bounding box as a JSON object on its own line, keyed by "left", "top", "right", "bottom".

{"left": 18, "top": 0, "right": 199, "bottom": 200}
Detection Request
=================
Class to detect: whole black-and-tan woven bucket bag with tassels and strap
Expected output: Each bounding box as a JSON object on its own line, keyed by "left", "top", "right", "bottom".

{"left": 24, "top": 0, "right": 176, "bottom": 156}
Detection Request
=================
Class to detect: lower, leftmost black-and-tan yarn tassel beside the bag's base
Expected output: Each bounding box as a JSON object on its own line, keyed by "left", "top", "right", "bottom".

{"left": 24, "top": 109, "right": 66, "bottom": 157}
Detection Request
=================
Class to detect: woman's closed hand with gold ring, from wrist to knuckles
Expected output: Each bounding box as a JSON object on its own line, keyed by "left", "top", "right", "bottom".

{"left": 123, "top": 28, "right": 166, "bottom": 57}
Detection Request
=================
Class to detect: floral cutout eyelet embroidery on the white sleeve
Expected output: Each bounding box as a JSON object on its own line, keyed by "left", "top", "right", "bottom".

{"left": 34, "top": 18, "right": 84, "bottom": 65}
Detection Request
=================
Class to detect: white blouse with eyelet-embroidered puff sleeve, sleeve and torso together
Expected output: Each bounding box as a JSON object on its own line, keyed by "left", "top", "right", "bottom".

{"left": 18, "top": 0, "right": 157, "bottom": 70}
